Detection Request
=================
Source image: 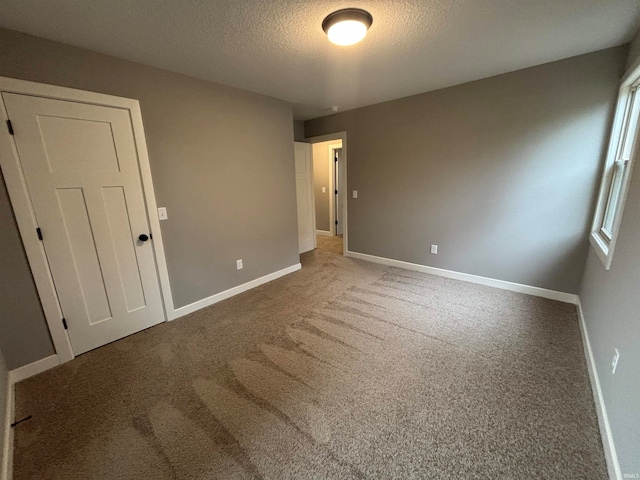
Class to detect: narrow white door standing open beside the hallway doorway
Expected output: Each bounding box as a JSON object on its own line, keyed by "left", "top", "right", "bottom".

{"left": 294, "top": 142, "right": 316, "bottom": 253}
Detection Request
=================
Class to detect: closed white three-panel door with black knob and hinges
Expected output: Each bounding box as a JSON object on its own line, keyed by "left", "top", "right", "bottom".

{"left": 2, "top": 93, "right": 164, "bottom": 355}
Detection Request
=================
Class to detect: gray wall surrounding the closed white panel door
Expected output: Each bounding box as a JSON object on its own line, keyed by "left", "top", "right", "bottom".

{"left": 0, "top": 29, "right": 299, "bottom": 368}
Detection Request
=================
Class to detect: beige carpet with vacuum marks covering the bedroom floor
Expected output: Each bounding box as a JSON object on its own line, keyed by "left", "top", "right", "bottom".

{"left": 14, "top": 237, "right": 607, "bottom": 480}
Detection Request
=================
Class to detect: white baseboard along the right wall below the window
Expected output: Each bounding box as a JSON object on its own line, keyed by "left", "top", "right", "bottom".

{"left": 577, "top": 299, "right": 622, "bottom": 480}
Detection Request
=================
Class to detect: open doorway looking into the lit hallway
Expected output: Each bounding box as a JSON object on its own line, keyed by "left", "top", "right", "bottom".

{"left": 307, "top": 132, "right": 348, "bottom": 253}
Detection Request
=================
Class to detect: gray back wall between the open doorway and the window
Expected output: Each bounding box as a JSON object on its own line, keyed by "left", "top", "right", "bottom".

{"left": 305, "top": 47, "right": 627, "bottom": 293}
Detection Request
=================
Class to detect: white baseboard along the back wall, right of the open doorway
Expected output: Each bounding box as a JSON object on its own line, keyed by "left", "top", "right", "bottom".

{"left": 345, "top": 250, "right": 578, "bottom": 305}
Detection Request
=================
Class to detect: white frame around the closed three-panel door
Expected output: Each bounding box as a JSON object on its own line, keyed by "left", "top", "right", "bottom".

{"left": 0, "top": 77, "right": 174, "bottom": 363}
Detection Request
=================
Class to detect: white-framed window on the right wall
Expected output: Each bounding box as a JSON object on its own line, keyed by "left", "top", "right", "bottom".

{"left": 589, "top": 59, "right": 640, "bottom": 270}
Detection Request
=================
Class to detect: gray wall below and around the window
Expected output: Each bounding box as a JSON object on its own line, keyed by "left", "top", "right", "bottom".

{"left": 580, "top": 41, "right": 640, "bottom": 474}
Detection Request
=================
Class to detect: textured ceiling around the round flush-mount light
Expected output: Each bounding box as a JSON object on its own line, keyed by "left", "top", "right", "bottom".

{"left": 0, "top": 0, "right": 640, "bottom": 119}
